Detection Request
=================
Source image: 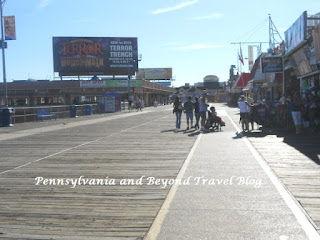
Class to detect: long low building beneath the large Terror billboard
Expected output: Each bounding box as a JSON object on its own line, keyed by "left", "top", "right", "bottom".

{"left": 0, "top": 79, "right": 174, "bottom": 106}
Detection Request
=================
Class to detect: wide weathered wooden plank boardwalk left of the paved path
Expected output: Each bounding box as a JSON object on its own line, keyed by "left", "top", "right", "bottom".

{"left": 0, "top": 107, "right": 197, "bottom": 240}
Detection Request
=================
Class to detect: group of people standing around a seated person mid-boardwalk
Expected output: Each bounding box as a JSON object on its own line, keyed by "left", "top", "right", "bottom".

{"left": 173, "top": 92, "right": 221, "bottom": 132}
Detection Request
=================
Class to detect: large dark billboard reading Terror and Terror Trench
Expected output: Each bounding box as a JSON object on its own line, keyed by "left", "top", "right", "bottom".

{"left": 52, "top": 37, "right": 138, "bottom": 76}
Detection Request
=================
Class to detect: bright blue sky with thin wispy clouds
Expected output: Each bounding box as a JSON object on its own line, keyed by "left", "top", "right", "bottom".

{"left": 0, "top": 0, "right": 320, "bottom": 87}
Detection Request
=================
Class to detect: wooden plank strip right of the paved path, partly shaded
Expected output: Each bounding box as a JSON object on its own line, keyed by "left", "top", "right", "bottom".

{"left": 228, "top": 105, "right": 320, "bottom": 234}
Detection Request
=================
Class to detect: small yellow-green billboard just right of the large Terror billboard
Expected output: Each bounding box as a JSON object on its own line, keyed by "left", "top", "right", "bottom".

{"left": 136, "top": 68, "right": 172, "bottom": 80}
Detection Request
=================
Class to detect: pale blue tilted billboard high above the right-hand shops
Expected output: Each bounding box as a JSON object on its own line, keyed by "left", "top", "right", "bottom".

{"left": 284, "top": 11, "right": 307, "bottom": 52}
